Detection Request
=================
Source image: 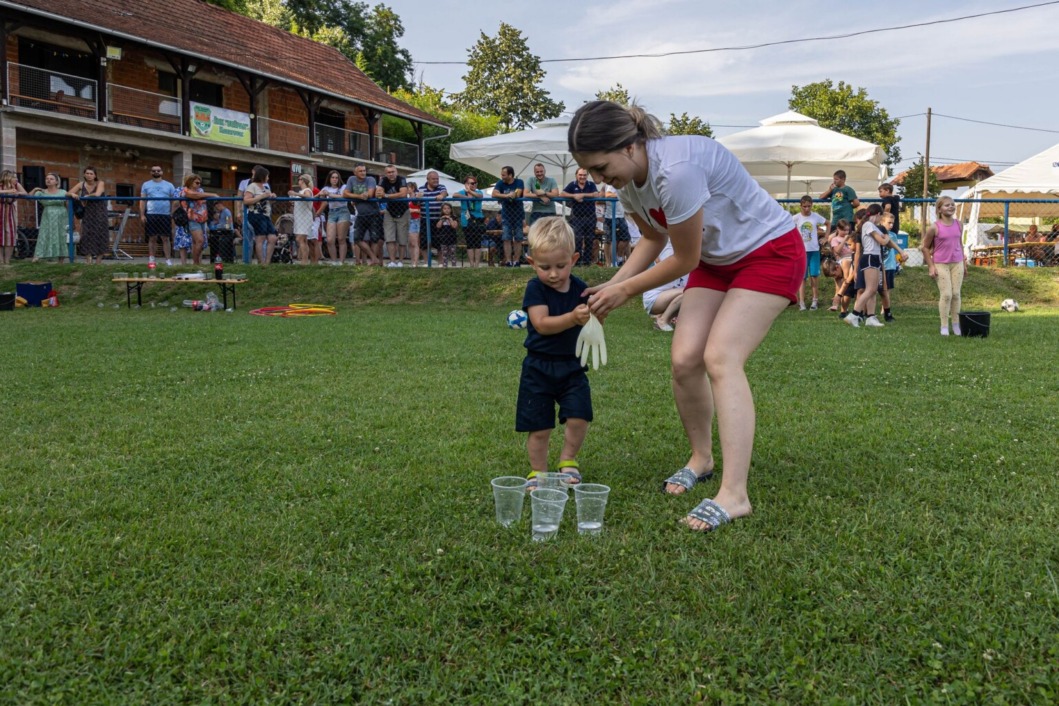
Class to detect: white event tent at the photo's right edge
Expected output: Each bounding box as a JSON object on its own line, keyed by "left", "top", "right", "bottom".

{"left": 956, "top": 144, "right": 1059, "bottom": 246}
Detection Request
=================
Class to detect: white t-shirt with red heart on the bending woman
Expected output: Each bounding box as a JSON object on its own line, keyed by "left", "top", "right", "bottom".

{"left": 621, "top": 135, "right": 793, "bottom": 265}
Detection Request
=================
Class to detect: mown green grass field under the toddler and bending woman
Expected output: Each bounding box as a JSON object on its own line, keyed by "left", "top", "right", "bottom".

{"left": 0, "top": 264, "right": 1059, "bottom": 704}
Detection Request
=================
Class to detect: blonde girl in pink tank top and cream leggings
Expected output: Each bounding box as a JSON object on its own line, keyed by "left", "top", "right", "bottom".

{"left": 922, "top": 196, "right": 967, "bottom": 336}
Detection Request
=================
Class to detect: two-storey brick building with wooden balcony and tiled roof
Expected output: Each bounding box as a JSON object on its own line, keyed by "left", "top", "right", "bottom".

{"left": 0, "top": 0, "right": 447, "bottom": 203}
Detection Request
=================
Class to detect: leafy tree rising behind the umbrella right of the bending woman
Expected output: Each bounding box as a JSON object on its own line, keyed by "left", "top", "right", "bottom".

{"left": 787, "top": 78, "right": 901, "bottom": 164}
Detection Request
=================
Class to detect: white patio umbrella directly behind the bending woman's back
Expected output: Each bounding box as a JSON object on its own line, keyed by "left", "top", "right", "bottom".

{"left": 717, "top": 111, "right": 886, "bottom": 198}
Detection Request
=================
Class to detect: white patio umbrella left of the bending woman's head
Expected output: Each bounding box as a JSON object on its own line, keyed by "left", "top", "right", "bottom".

{"left": 449, "top": 117, "right": 577, "bottom": 188}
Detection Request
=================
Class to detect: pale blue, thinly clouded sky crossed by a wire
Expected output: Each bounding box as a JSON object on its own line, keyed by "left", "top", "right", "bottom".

{"left": 381, "top": 0, "right": 1059, "bottom": 179}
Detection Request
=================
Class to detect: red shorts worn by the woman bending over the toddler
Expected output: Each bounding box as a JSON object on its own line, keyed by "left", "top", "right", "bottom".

{"left": 687, "top": 229, "right": 805, "bottom": 302}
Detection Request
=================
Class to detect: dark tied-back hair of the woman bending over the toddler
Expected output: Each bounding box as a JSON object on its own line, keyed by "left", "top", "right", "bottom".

{"left": 567, "top": 101, "right": 663, "bottom": 152}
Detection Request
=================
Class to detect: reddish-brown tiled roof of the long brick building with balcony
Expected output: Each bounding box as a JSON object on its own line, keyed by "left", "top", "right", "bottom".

{"left": 0, "top": 0, "right": 445, "bottom": 126}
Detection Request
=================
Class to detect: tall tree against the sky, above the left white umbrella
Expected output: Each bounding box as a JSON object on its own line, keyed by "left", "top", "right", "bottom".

{"left": 456, "top": 22, "right": 566, "bottom": 131}
